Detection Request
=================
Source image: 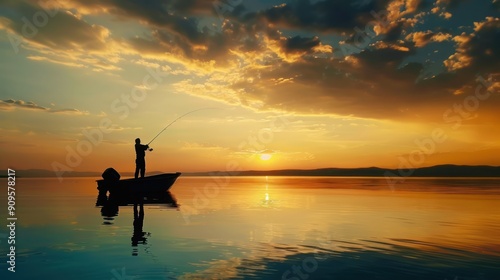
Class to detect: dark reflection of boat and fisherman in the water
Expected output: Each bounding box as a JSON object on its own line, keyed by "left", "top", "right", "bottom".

{"left": 96, "top": 187, "right": 179, "bottom": 256}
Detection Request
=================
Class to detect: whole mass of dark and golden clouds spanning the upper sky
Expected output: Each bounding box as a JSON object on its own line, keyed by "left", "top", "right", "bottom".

{"left": 0, "top": 0, "right": 500, "bottom": 124}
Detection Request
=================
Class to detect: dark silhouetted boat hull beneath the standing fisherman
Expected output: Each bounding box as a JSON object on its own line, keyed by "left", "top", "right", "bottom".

{"left": 96, "top": 172, "right": 181, "bottom": 205}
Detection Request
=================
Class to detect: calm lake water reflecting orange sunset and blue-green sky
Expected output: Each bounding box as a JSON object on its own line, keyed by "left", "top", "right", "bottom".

{"left": 0, "top": 176, "right": 500, "bottom": 280}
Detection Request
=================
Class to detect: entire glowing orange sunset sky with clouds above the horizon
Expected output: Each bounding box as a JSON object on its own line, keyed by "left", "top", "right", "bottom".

{"left": 0, "top": 0, "right": 500, "bottom": 175}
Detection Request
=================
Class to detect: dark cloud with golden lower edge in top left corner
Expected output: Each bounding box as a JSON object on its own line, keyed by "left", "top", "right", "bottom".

{"left": 0, "top": 1, "right": 121, "bottom": 71}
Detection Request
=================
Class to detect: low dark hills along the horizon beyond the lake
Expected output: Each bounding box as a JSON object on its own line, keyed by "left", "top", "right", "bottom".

{"left": 1, "top": 164, "right": 500, "bottom": 178}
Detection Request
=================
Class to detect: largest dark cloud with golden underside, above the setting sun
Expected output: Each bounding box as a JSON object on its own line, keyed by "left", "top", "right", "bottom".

{"left": 117, "top": 1, "right": 491, "bottom": 123}
